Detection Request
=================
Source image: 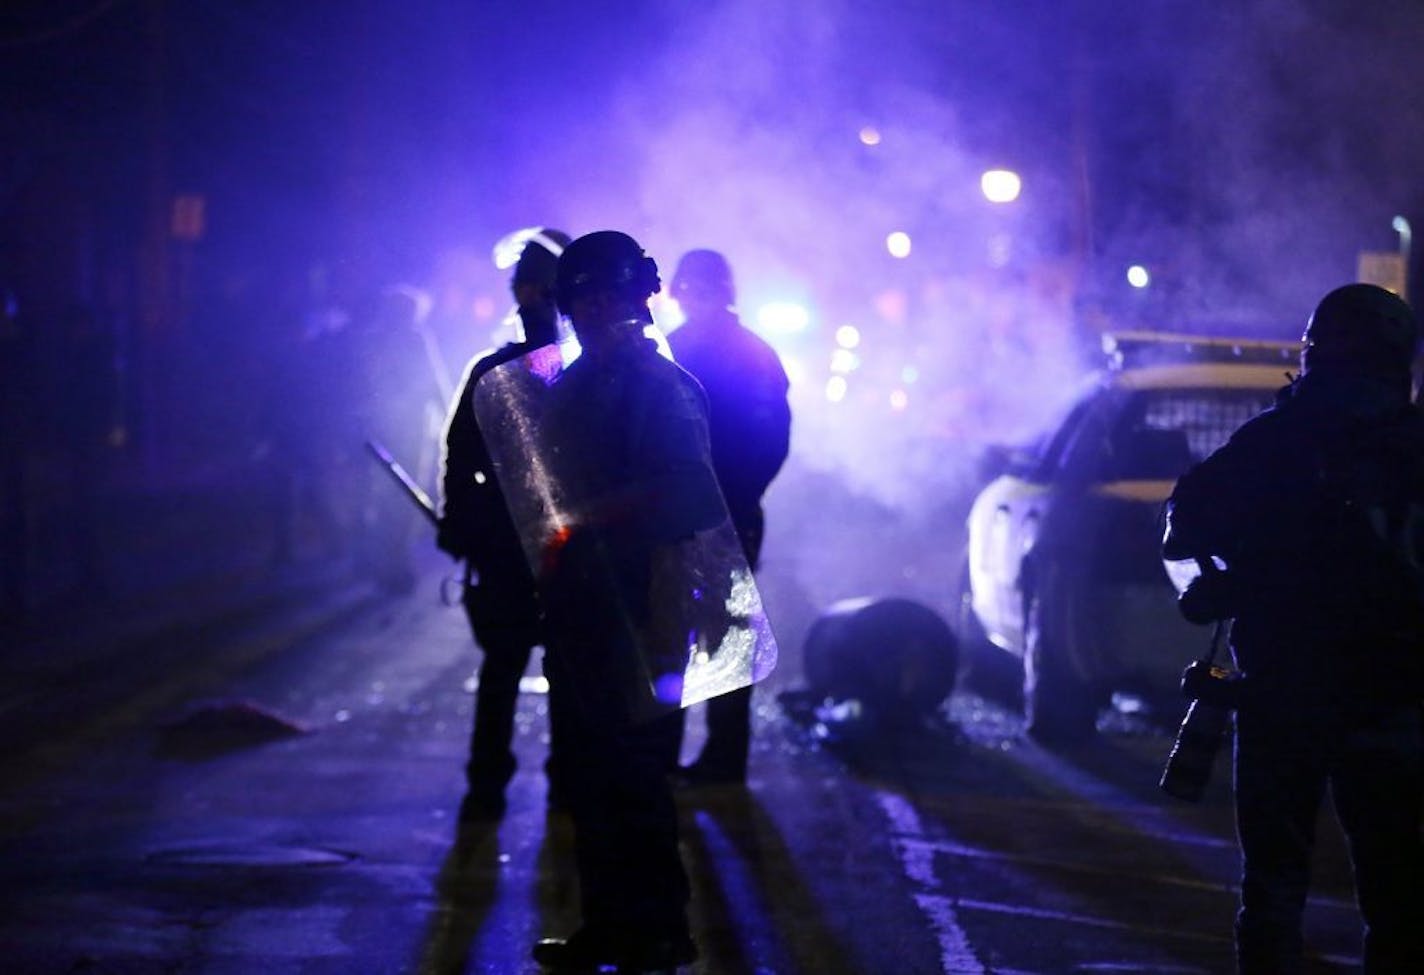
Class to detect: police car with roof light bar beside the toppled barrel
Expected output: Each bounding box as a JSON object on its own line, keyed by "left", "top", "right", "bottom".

{"left": 960, "top": 332, "right": 1300, "bottom": 742}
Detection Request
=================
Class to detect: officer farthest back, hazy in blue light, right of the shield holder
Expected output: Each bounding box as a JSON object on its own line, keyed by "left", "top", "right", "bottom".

{"left": 657, "top": 249, "right": 792, "bottom": 784}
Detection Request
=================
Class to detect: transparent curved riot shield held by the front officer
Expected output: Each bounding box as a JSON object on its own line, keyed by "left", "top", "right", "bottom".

{"left": 474, "top": 334, "right": 776, "bottom": 720}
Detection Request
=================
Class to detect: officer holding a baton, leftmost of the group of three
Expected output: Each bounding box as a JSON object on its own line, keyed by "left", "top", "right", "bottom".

{"left": 436, "top": 228, "right": 571, "bottom": 821}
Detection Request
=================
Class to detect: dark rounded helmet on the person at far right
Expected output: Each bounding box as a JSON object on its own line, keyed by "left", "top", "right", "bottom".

{"left": 1302, "top": 285, "right": 1418, "bottom": 376}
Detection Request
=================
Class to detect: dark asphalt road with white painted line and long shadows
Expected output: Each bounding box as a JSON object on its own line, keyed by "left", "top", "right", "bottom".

{"left": 0, "top": 557, "right": 1358, "bottom": 975}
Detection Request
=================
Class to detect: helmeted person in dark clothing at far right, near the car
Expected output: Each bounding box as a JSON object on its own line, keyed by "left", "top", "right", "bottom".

{"left": 1163, "top": 285, "right": 1424, "bottom": 975}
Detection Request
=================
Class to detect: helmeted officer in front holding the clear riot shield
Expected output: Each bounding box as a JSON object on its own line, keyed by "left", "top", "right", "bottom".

{"left": 534, "top": 231, "right": 726, "bottom": 972}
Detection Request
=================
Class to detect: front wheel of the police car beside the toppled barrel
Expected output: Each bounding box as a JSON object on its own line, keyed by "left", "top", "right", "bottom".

{"left": 1024, "top": 577, "right": 1101, "bottom": 744}
